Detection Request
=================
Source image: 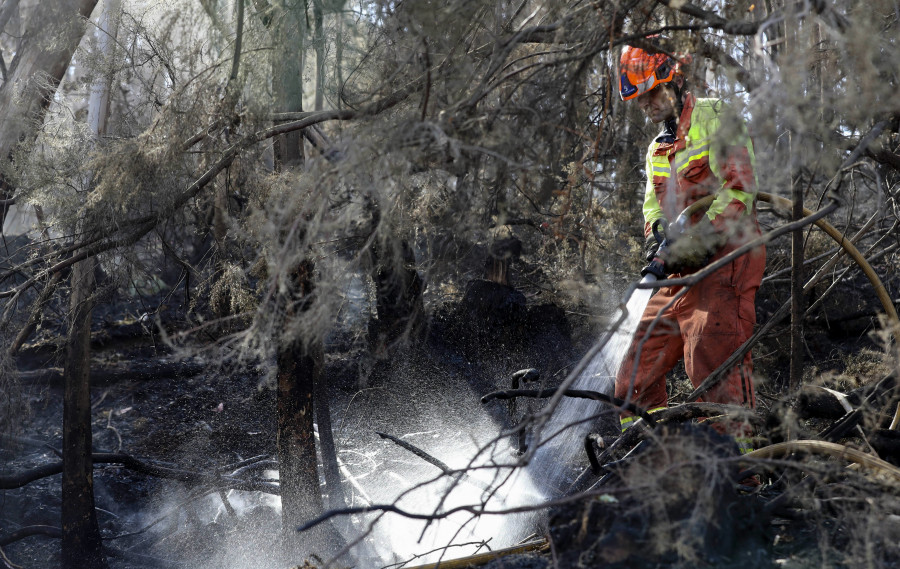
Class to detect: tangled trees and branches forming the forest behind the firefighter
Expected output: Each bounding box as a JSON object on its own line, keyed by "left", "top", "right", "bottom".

{"left": 0, "top": 0, "right": 900, "bottom": 567}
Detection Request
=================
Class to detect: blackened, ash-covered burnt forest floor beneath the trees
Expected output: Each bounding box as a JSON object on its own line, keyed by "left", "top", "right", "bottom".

{"left": 0, "top": 260, "right": 900, "bottom": 569}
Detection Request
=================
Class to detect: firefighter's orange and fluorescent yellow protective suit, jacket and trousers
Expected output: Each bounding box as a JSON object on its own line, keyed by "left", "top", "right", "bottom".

{"left": 615, "top": 93, "right": 765, "bottom": 425}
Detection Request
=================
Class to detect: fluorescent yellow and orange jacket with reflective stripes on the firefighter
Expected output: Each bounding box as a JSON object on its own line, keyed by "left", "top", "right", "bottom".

{"left": 644, "top": 93, "right": 758, "bottom": 240}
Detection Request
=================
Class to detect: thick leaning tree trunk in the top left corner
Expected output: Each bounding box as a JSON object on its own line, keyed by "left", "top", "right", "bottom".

{"left": 0, "top": 0, "right": 97, "bottom": 227}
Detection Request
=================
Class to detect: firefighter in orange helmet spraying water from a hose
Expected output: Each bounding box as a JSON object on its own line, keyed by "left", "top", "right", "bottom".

{"left": 615, "top": 38, "right": 765, "bottom": 444}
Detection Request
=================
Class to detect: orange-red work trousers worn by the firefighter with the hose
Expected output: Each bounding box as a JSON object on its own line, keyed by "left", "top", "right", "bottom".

{"left": 616, "top": 247, "right": 766, "bottom": 409}
